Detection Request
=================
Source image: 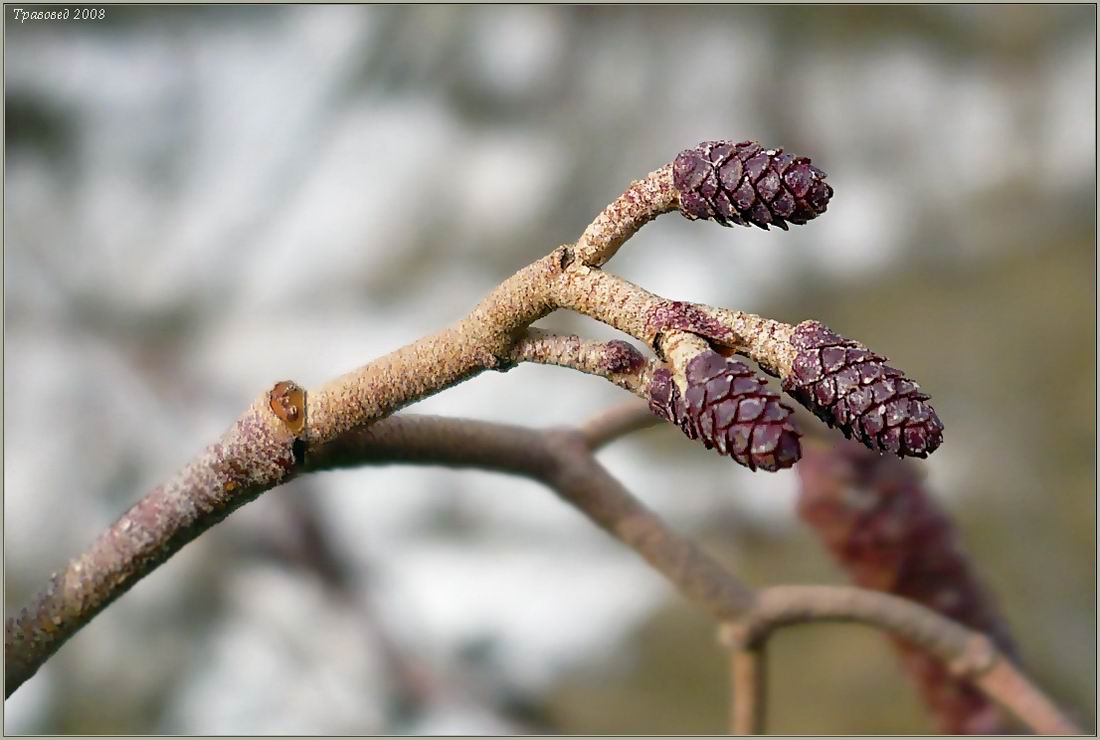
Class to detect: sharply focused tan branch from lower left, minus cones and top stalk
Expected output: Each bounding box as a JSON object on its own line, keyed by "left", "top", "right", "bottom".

{"left": 6, "top": 239, "right": 800, "bottom": 693}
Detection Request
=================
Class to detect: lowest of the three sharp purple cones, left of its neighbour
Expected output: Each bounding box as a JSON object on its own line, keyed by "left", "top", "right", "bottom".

{"left": 649, "top": 350, "right": 802, "bottom": 472}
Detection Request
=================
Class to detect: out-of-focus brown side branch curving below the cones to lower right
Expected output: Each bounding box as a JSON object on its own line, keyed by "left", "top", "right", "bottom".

{"left": 8, "top": 404, "right": 1076, "bottom": 732}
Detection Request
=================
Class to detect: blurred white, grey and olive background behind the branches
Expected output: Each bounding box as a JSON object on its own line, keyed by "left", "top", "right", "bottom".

{"left": 3, "top": 5, "right": 1097, "bottom": 733}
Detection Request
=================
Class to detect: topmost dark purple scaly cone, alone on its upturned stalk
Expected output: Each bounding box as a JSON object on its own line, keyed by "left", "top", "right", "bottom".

{"left": 672, "top": 141, "right": 833, "bottom": 231}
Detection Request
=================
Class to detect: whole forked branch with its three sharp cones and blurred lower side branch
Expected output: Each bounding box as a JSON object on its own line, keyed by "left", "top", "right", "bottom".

{"left": 4, "top": 141, "right": 1073, "bottom": 731}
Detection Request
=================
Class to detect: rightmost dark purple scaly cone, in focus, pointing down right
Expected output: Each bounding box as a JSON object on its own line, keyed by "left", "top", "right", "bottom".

{"left": 783, "top": 321, "right": 944, "bottom": 457}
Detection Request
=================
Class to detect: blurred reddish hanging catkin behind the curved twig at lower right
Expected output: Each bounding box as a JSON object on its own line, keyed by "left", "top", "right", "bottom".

{"left": 798, "top": 441, "right": 1015, "bottom": 735}
